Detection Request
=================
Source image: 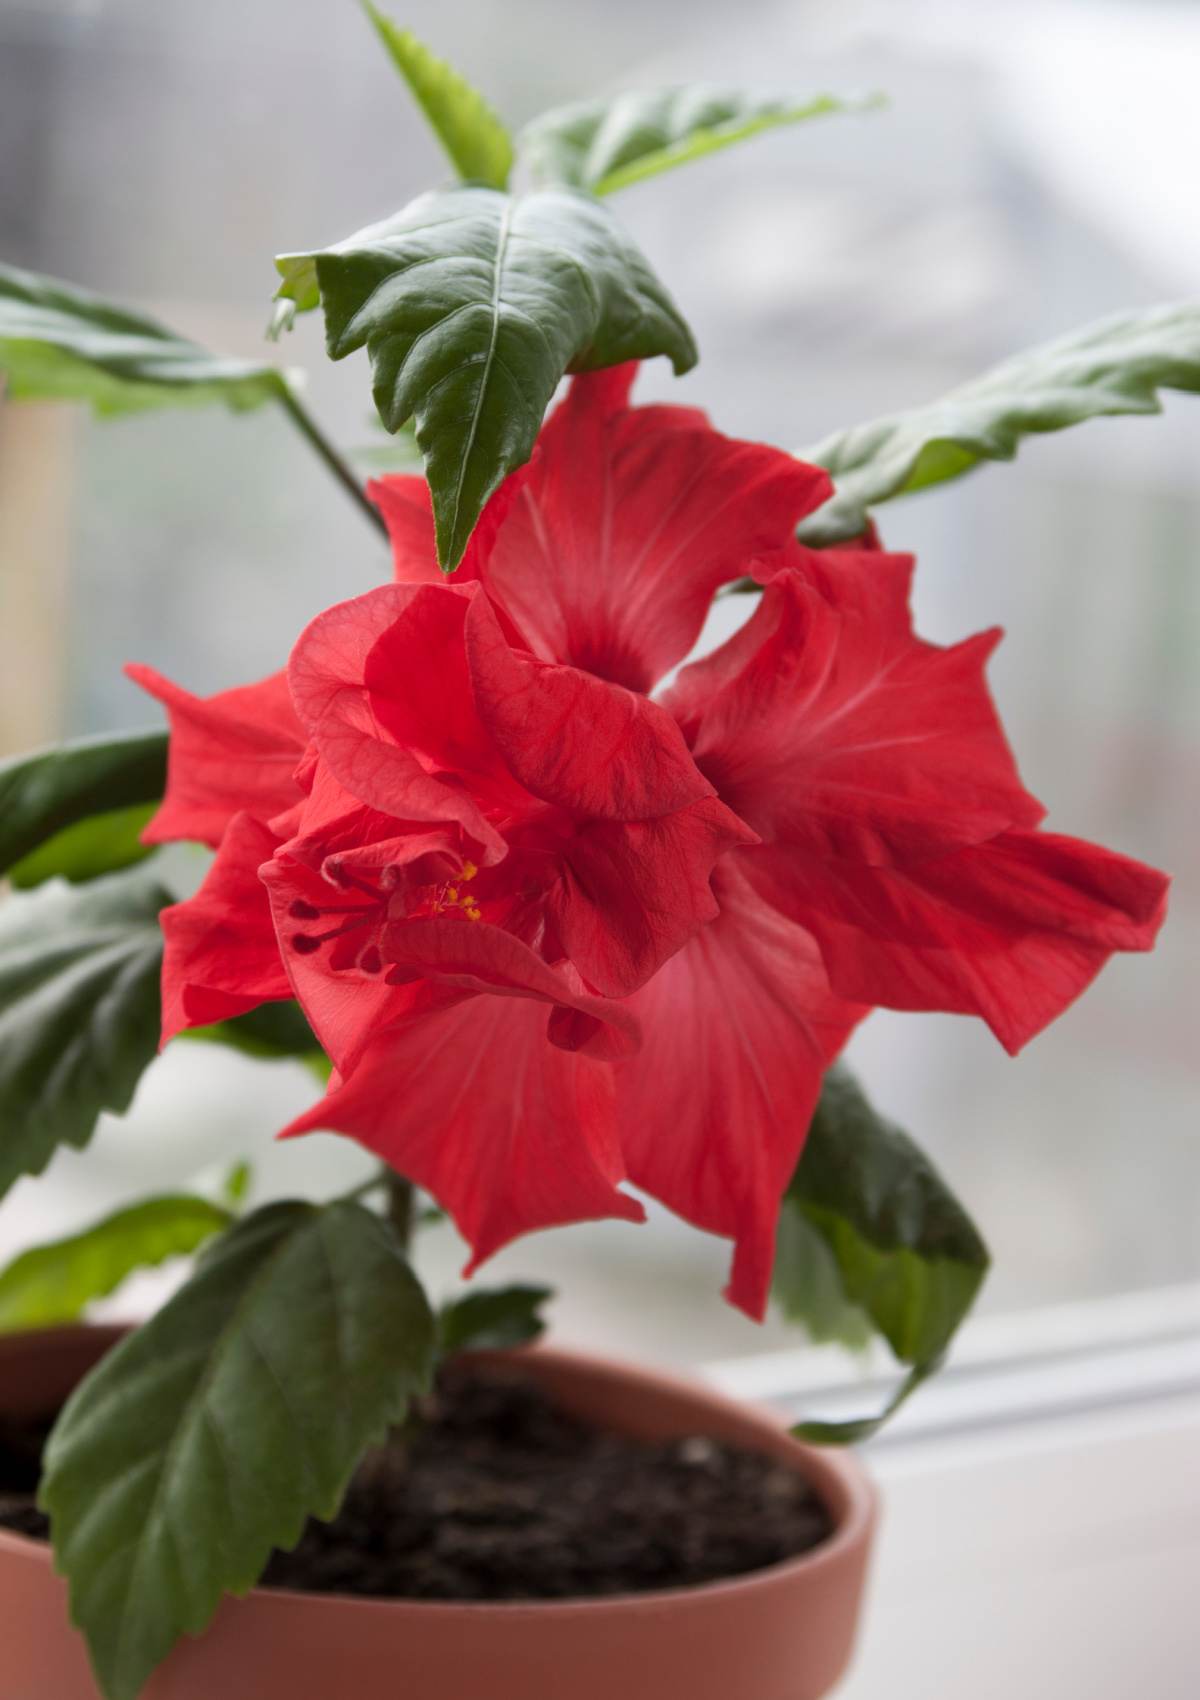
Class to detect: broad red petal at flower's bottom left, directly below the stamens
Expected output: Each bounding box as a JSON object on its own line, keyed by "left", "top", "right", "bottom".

{"left": 284, "top": 996, "right": 644, "bottom": 1273}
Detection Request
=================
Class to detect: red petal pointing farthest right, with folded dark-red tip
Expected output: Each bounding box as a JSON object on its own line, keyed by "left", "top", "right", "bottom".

{"left": 746, "top": 831, "right": 1168, "bottom": 1052}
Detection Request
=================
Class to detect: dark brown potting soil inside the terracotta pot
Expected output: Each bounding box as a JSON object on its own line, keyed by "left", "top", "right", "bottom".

{"left": 0, "top": 1365, "right": 831, "bottom": 1600}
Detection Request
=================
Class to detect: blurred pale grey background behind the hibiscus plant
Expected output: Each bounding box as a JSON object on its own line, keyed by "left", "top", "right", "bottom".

{"left": 0, "top": 0, "right": 1200, "bottom": 1360}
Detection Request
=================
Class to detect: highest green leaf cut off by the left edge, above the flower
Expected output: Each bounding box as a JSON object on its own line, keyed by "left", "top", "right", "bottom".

{"left": 0, "top": 265, "right": 287, "bottom": 413}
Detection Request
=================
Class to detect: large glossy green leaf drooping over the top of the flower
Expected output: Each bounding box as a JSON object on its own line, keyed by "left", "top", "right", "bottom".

{"left": 275, "top": 189, "right": 697, "bottom": 571}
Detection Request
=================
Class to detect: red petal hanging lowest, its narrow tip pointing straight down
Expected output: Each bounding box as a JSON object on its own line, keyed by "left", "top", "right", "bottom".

{"left": 617, "top": 850, "right": 867, "bottom": 1318}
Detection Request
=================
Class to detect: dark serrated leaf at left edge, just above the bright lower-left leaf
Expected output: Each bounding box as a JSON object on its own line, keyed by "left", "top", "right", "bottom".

{"left": 0, "top": 870, "right": 172, "bottom": 1197}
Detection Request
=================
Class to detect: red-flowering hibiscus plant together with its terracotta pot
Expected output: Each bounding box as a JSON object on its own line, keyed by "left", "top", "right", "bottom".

{"left": 0, "top": 10, "right": 1200, "bottom": 1700}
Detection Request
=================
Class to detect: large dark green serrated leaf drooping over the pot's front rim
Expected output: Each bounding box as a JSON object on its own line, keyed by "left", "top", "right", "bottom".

{"left": 42, "top": 1202, "right": 433, "bottom": 1700}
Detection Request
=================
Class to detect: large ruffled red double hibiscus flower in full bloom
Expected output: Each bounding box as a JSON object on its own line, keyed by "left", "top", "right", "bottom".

{"left": 138, "top": 367, "right": 1166, "bottom": 1316}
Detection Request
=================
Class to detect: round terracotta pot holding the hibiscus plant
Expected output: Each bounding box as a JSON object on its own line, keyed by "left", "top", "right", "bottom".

{"left": 0, "top": 1328, "right": 875, "bottom": 1700}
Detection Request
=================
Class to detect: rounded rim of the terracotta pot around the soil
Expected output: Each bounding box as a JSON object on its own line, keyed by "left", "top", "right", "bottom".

{"left": 0, "top": 1323, "right": 879, "bottom": 1620}
